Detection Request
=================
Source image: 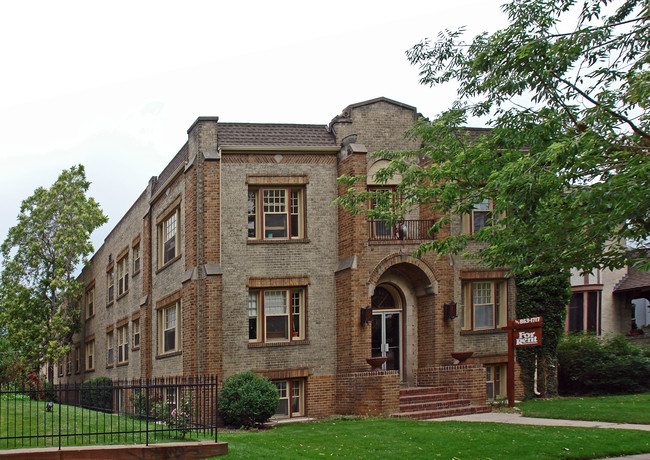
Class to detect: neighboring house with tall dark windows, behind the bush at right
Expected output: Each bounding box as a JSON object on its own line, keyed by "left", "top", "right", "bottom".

{"left": 565, "top": 260, "right": 650, "bottom": 335}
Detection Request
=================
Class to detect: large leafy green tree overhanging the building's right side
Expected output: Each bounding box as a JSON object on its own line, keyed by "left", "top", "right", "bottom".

{"left": 339, "top": 0, "right": 650, "bottom": 275}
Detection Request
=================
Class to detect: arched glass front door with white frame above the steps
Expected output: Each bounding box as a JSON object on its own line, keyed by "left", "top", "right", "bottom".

{"left": 372, "top": 284, "right": 404, "bottom": 373}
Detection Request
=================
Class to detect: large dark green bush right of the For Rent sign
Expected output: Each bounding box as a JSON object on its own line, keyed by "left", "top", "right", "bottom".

{"left": 558, "top": 334, "right": 650, "bottom": 394}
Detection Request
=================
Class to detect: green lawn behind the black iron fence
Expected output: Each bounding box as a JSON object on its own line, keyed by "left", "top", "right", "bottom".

{"left": 0, "top": 398, "right": 208, "bottom": 449}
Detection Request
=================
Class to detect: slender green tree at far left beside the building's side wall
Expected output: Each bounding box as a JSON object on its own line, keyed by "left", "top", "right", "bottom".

{"left": 0, "top": 165, "right": 107, "bottom": 365}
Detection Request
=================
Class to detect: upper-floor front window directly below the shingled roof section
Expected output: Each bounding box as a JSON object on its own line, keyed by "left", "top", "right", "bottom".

{"left": 248, "top": 187, "right": 305, "bottom": 240}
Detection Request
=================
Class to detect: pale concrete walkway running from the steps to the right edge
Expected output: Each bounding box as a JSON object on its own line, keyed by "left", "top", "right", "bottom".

{"left": 430, "top": 412, "right": 650, "bottom": 431}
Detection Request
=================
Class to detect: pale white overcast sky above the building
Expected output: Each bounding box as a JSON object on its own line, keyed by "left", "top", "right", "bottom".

{"left": 0, "top": 0, "right": 507, "bottom": 255}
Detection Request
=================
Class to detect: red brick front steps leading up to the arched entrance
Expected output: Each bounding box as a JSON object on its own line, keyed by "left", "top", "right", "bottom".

{"left": 391, "top": 387, "right": 492, "bottom": 420}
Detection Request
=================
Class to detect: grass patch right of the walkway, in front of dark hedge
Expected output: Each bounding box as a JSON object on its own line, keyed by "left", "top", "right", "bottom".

{"left": 518, "top": 393, "right": 650, "bottom": 425}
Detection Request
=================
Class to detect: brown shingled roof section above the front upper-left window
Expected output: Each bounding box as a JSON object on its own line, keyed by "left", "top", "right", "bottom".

{"left": 217, "top": 123, "right": 337, "bottom": 148}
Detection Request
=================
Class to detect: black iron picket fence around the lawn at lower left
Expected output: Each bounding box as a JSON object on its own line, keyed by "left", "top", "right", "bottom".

{"left": 0, "top": 376, "right": 217, "bottom": 449}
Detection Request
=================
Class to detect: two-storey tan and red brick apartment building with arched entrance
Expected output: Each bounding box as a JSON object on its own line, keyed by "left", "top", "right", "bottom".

{"left": 58, "top": 98, "right": 515, "bottom": 417}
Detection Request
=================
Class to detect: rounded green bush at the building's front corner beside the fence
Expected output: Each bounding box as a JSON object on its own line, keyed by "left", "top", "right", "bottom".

{"left": 219, "top": 371, "right": 280, "bottom": 427}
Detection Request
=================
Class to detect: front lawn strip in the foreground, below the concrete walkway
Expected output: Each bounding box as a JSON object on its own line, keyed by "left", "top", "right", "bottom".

{"left": 219, "top": 419, "right": 650, "bottom": 460}
